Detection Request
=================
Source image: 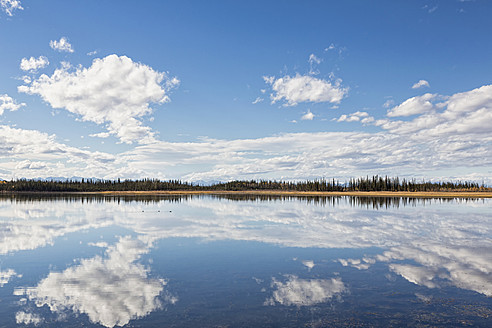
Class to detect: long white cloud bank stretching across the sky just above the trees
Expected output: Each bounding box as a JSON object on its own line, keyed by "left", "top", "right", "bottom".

{"left": 0, "top": 78, "right": 492, "bottom": 183}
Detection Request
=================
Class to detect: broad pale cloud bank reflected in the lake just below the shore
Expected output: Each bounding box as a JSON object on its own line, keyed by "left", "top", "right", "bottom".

{"left": 0, "top": 197, "right": 492, "bottom": 296}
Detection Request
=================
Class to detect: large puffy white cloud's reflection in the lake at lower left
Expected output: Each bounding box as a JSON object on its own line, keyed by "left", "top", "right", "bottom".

{"left": 19, "top": 237, "right": 177, "bottom": 327}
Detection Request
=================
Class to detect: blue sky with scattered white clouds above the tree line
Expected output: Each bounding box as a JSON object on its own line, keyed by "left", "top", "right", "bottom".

{"left": 0, "top": 0, "right": 492, "bottom": 185}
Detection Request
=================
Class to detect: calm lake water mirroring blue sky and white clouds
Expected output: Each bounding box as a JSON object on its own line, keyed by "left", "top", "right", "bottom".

{"left": 0, "top": 196, "right": 492, "bottom": 327}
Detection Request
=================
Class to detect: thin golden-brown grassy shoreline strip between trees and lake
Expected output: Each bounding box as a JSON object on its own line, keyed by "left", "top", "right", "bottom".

{"left": 0, "top": 190, "right": 492, "bottom": 198}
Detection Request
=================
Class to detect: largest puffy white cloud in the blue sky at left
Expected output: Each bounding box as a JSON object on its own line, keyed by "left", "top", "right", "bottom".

{"left": 19, "top": 55, "right": 179, "bottom": 143}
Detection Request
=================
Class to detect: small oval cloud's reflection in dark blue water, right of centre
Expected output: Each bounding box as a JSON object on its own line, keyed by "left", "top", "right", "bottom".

{"left": 265, "top": 275, "right": 346, "bottom": 306}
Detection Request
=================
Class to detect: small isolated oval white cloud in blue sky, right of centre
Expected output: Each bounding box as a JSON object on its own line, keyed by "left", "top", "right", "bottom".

{"left": 264, "top": 74, "right": 348, "bottom": 106}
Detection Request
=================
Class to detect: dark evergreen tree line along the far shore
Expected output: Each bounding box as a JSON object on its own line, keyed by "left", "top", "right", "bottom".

{"left": 0, "top": 175, "right": 486, "bottom": 192}
